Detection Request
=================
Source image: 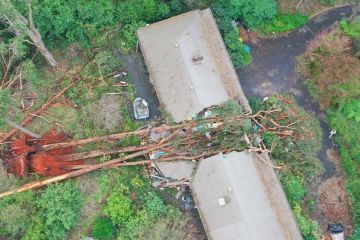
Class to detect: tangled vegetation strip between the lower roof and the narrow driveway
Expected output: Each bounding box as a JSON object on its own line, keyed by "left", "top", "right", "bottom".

{"left": 250, "top": 96, "right": 322, "bottom": 240}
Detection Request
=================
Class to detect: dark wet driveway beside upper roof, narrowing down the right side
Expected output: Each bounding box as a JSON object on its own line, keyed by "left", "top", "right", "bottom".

{"left": 237, "top": 6, "right": 352, "bottom": 180}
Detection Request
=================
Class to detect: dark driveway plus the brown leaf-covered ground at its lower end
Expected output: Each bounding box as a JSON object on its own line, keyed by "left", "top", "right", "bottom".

{"left": 237, "top": 6, "right": 352, "bottom": 233}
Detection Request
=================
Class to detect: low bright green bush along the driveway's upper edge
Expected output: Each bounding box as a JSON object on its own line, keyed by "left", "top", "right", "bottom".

{"left": 258, "top": 13, "right": 308, "bottom": 34}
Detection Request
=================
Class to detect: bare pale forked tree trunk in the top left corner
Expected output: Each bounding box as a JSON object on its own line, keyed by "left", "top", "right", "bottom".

{"left": 0, "top": 0, "right": 58, "bottom": 67}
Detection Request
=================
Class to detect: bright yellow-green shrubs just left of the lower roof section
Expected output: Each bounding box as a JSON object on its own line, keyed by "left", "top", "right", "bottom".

{"left": 100, "top": 167, "right": 181, "bottom": 240}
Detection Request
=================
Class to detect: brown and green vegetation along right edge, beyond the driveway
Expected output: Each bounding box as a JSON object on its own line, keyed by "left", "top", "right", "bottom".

{"left": 302, "top": 20, "right": 360, "bottom": 239}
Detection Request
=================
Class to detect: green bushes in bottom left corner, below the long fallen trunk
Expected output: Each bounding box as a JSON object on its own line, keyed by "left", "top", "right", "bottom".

{"left": 0, "top": 182, "right": 82, "bottom": 240}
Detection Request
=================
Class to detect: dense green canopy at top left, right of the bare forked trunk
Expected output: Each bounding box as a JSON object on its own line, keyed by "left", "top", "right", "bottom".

{"left": 26, "top": 0, "right": 116, "bottom": 47}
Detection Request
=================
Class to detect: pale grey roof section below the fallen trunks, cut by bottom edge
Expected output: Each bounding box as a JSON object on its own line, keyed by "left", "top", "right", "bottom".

{"left": 190, "top": 152, "right": 302, "bottom": 240}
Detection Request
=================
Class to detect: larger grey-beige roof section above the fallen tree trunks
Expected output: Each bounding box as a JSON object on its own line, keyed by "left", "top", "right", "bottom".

{"left": 137, "top": 9, "right": 251, "bottom": 122}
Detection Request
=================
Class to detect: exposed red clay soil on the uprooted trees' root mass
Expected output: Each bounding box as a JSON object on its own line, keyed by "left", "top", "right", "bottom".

{"left": 2, "top": 130, "right": 84, "bottom": 177}
